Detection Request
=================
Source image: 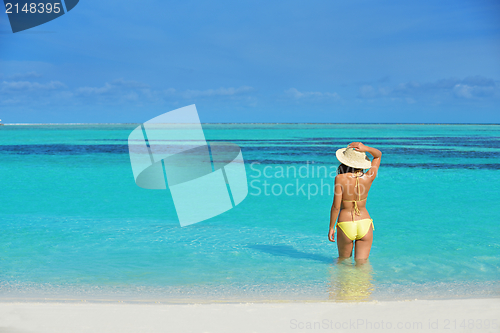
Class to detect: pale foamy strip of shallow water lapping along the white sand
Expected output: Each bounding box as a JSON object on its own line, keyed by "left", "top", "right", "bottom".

{"left": 0, "top": 281, "right": 500, "bottom": 304}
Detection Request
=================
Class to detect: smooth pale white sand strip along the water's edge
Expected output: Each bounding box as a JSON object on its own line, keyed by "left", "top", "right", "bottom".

{"left": 0, "top": 298, "right": 500, "bottom": 333}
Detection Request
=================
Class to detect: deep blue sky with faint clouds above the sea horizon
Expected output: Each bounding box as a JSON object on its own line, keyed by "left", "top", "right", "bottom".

{"left": 0, "top": 0, "right": 500, "bottom": 123}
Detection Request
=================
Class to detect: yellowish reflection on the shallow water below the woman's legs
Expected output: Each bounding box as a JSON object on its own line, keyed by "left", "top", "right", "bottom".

{"left": 328, "top": 258, "right": 374, "bottom": 301}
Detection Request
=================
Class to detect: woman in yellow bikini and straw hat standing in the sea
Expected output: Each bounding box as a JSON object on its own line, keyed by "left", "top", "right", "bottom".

{"left": 328, "top": 142, "right": 382, "bottom": 259}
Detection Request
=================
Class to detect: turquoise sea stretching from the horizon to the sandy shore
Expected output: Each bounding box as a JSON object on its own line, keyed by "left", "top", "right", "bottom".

{"left": 0, "top": 124, "right": 500, "bottom": 300}
